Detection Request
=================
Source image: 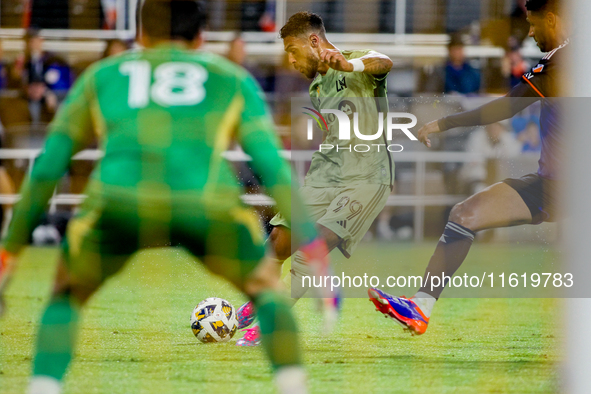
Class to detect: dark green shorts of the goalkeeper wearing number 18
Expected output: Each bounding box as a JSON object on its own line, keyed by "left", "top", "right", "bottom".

{"left": 63, "top": 188, "right": 265, "bottom": 288}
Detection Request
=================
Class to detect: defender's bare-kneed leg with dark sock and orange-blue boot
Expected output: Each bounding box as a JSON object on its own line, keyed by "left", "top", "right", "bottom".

{"left": 368, "top": 182, "right": 532, "bottom": 335}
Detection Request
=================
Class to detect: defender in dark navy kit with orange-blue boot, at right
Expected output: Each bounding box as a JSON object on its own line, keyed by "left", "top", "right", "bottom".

{"left": 369, "top": 0, "right": 569, "bottom": 334}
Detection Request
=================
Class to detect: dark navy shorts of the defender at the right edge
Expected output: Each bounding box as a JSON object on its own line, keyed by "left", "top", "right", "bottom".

{"left": 503, "top": 174, "right": 557, "bottom": 224}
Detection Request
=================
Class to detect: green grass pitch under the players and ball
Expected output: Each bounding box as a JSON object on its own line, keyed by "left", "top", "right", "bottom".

{"left": 0, "top": 245, "right": 562, "bottom": 394}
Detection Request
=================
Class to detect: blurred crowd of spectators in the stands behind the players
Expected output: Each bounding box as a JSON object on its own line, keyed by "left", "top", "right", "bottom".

{"left": 0, "top": 0, "right": 552, "bottom": 240}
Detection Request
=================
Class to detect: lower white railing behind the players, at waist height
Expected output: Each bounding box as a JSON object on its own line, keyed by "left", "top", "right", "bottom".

{"left": 0, "top": 149, "right": 500, "bottom": 241}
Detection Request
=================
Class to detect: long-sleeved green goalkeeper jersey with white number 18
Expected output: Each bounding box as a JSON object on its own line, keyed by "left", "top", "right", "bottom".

{"left": 4, "top": 45, "right": 316, "bottom": 252}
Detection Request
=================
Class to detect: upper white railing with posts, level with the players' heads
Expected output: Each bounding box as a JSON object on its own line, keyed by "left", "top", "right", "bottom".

{"left": 0, "top": 0, "right": 541, "bottom": 59}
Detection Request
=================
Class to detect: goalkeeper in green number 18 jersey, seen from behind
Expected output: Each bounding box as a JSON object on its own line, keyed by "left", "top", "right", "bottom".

{"left": 0, "top": 0, "right": 327, "bottom": 393}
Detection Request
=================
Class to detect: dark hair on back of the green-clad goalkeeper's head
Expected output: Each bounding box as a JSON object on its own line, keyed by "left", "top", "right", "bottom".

{"left": 141, "top": 0, "right": 207, "bottom": 41}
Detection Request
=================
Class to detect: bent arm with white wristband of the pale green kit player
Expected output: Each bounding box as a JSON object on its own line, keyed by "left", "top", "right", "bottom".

{"left": 320, "top": 49, "right": 394, "bottom": 75}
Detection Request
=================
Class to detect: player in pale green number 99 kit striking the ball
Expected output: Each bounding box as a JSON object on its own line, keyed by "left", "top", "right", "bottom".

{"left": 236, "top": 12, "right": 394, "bottom": 346}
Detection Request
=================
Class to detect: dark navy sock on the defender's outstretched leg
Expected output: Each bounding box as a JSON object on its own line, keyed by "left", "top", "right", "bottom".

{"left": 419, "top": 222, "right": 476, "bottom": 298}
